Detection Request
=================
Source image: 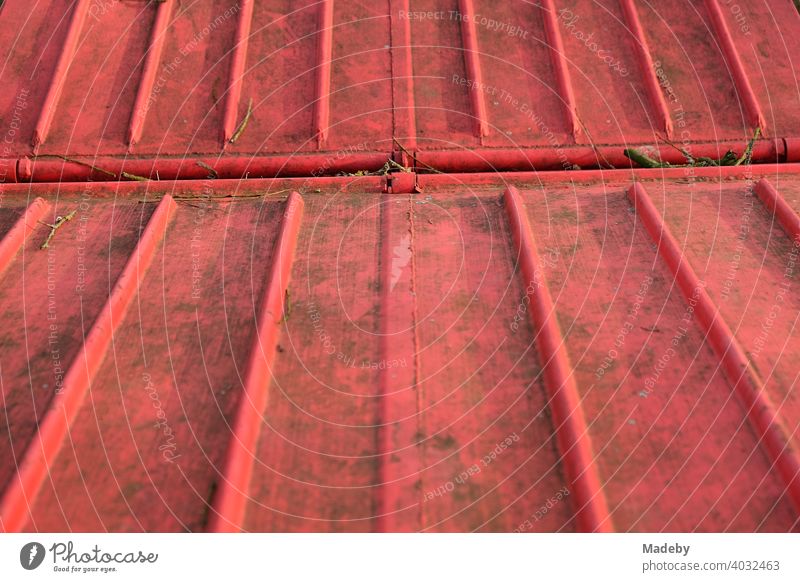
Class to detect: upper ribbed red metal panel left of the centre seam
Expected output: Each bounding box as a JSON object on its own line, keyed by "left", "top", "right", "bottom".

{"left": 0, "top": 0, "right": 392, "bottom": 177}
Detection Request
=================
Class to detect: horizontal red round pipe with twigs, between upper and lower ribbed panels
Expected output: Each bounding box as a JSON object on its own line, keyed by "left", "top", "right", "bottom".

{"left": 0, "top": 140, "right": 790, "bottom": 182}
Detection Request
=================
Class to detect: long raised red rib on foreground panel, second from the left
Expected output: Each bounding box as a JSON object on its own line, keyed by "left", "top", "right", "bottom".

{"left": 0, "top": 195, "right": 175, "bottom": 532}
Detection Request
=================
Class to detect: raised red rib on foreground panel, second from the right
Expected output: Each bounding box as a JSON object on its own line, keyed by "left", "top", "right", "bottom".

{"left": 628, "top": 182, "right": 800, "bottom": 514}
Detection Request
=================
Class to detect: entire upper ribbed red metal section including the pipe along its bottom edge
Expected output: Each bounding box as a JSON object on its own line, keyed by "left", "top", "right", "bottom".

{"left": 0, "top": 0, "right": 800, "bottom": 181}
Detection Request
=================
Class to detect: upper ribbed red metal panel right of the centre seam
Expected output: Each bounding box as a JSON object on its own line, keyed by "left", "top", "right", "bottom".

{"left": 411, "top": 0, "right": 800, "bottom": 148}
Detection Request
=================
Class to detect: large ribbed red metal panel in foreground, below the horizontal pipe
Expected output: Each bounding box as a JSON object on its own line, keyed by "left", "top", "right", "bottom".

{"left": 0, "top": 166, "right": 800, "bottom": 531}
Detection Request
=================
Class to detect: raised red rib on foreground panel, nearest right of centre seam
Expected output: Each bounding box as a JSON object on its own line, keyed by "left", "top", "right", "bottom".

{"left": 504, "top": 186, "right": 613, "bottom": 532}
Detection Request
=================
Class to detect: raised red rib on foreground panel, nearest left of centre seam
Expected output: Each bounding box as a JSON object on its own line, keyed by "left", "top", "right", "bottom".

{"left": 206, "top": 192, "right": 304, "bottom": 532}
